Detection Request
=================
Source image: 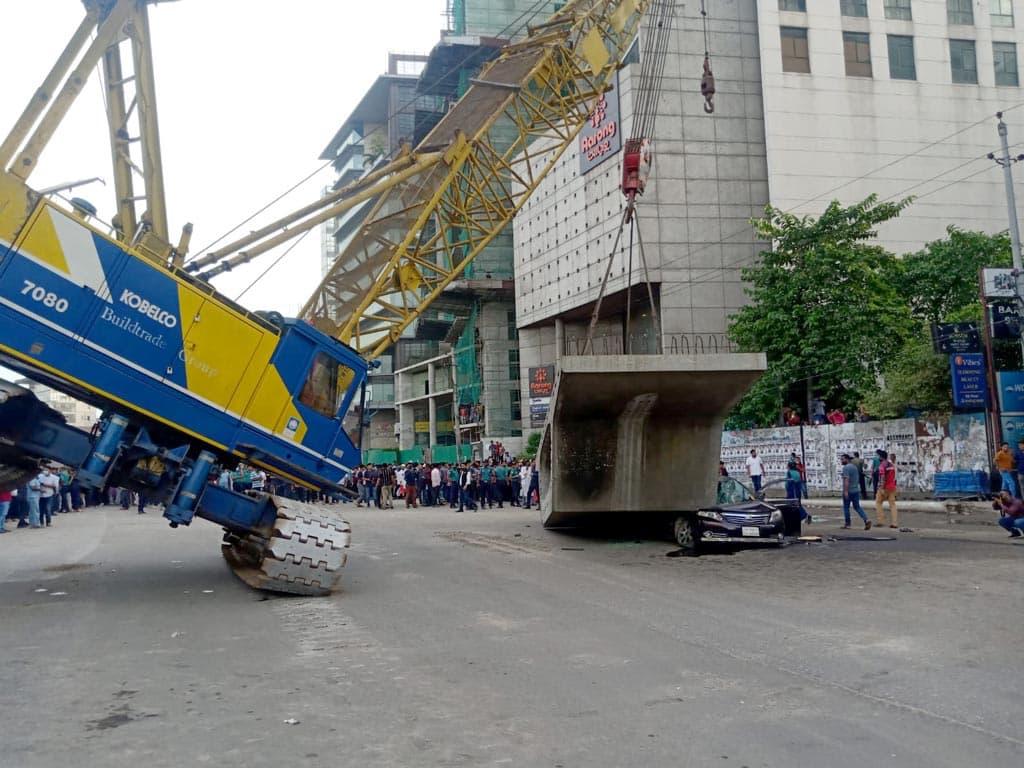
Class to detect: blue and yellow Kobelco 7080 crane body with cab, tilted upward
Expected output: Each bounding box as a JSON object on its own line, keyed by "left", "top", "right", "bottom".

{"left": 0, "top": 200, "right": 368, "bottom": 592}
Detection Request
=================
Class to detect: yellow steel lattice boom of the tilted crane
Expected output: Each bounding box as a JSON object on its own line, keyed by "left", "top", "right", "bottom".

{"left": 301, "top": 0, "right": 649, "bottom": 358}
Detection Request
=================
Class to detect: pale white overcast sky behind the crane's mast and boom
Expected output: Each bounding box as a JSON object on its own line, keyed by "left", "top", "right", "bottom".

{"left": 0, "top": 0, "right": 445, "bottom": 315}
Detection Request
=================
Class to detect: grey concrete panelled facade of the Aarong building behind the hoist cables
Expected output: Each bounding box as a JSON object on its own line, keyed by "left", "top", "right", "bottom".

{"left": 515, "top": 0, "right": 768, "bottom": 339}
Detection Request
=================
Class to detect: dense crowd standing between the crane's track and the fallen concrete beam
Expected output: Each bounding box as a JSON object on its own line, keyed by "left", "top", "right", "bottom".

{"left": 343, "top": 460, "right": 541, "bottom": 512}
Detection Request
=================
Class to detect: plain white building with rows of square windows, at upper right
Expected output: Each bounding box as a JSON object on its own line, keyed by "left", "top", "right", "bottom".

{"left": 757, "top": 0, "right": 1024, "bottom": 254}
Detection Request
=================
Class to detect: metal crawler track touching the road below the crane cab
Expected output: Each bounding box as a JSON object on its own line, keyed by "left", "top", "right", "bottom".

{"left": 221, "top": 497, "right": 351, "bottom": 595}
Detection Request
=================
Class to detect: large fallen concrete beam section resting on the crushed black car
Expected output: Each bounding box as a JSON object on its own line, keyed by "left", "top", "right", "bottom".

{"left": 538, "top": 353, "right": 766, "bottom": 527}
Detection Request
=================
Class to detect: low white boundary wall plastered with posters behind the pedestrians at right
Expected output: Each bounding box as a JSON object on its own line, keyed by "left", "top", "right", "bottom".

{"left": 722, "top": 413, "right": 989, "bottom": 494}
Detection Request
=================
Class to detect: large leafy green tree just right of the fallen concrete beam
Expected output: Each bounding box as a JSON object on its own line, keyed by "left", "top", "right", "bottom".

{"left": 729, "top": 196, "right": 912, "bottom": 424}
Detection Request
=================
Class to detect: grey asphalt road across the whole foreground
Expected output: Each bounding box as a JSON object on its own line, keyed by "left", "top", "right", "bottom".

{"left": 0, "top": 507, "right": 1024, "bottom": 768}
